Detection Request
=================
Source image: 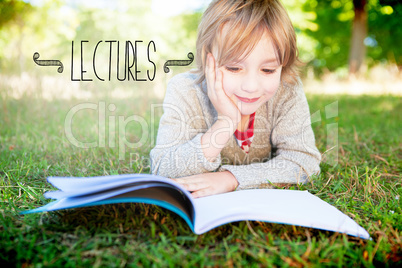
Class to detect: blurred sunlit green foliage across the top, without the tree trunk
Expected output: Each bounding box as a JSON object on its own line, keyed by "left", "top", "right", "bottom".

{"left": 0, "top": 0, "right": 402, "bottom": 78}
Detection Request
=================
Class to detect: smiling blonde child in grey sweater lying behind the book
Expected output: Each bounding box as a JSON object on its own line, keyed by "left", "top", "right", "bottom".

{"left": 150, "top": 0, "right": 321, "bottom": 197}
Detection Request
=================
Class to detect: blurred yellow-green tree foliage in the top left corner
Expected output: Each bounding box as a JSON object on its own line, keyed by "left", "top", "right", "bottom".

{"left": 0, "top": 0, "right": 69, "bottom": 74}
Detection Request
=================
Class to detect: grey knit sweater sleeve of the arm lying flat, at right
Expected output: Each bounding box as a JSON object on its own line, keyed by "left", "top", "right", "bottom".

{"left": 219, "top": 82, "right": 321, "bottom": 189}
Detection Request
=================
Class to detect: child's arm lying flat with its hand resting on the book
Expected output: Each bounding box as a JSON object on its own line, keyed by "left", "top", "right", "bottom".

{"left": 173, "top": 79, "right": 321, "bottom": 197}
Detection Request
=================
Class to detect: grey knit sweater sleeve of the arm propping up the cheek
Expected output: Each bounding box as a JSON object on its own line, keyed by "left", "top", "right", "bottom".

{"left": 150, "top": 74, "right": 221, "bottom": 178}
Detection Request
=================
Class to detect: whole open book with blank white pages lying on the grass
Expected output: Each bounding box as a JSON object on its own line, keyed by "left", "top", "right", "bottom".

{"left": 23, "top": 174, "right": 370, "bottom": 239}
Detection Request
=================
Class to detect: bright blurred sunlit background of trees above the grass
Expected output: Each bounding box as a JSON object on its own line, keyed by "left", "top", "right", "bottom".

{"left": 0, "top": 0, "right": 402, "bottom": 100}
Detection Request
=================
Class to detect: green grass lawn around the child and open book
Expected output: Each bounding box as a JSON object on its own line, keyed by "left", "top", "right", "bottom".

{"left": 0, "top": 92, "right": 402, "bottom": 267}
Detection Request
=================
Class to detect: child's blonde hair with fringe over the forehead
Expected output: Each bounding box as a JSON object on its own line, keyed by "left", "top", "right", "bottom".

{"left": 196, "top": 0, "right": 301, "bottom": 84}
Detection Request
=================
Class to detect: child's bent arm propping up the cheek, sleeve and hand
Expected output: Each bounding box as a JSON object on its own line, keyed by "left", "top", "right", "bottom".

{"left": 150, "top": 55, "right": 241, "bottom": 180}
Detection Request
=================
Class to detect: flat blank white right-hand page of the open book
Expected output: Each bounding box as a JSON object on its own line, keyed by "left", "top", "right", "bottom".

{"left": 194, "top": 189, "right": 369, "bottom": 239}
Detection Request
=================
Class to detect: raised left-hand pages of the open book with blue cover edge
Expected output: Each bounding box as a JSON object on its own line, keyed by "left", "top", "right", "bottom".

{"left": 25, "top": 174, "right": 195, "bottom": 224}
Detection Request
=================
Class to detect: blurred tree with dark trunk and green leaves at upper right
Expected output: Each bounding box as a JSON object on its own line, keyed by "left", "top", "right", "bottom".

{"left": 303, "top": 0, "right": 402, "bottom": 76}
